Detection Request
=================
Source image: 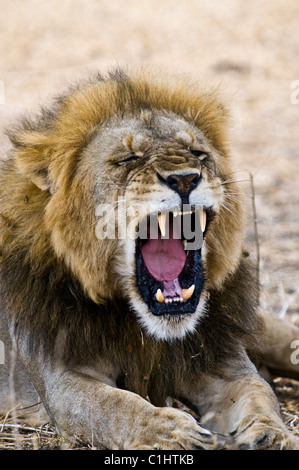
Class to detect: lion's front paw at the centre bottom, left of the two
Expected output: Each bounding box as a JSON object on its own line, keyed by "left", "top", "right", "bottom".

{"left": 127, "top": 408, "right": 223, "bottom": 450}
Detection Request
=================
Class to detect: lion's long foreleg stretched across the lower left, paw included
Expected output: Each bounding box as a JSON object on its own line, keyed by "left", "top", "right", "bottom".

{"left": 12, "top": 326, "right": 217, "bottom": 450}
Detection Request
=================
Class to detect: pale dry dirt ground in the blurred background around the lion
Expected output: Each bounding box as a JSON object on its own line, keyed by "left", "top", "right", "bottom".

{"left": 0, "top": 0, "right": 299, "bottom": 448}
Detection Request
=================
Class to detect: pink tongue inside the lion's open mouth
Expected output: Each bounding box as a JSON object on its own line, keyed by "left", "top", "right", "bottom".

{"left": 141, "top": 237, "right": 186, "bottom": 286}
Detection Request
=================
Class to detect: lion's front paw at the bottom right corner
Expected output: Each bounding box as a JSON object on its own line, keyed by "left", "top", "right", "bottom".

{"left": 231, "top": 415, "right": 299, "bottom": 450}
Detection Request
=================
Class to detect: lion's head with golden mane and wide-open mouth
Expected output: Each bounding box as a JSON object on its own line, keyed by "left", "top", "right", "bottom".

{"left": 11, "top": 72, "right": 244, "bottom": 340}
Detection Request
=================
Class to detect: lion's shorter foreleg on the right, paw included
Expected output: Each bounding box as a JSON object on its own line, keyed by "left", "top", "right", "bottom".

{"left": 193, "top": 369, "right": 299, "bottom": 449}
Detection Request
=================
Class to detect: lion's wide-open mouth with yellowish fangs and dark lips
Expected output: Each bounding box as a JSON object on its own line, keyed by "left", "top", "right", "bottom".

{"left": 136, "top": 209, "right": 208, "bottom": 315}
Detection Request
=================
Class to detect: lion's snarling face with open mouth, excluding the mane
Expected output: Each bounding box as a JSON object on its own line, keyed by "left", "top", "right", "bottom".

{"left": 85, "top": 112, "right": 234, "bottom": 339}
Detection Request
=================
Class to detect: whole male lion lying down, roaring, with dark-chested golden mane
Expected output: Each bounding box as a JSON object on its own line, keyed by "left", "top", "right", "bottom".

{"left": 0, "top": 70, "right": 299, "bottom": 450}
